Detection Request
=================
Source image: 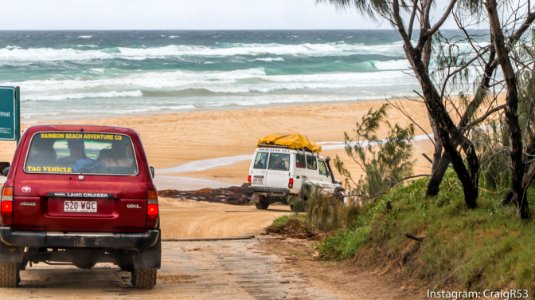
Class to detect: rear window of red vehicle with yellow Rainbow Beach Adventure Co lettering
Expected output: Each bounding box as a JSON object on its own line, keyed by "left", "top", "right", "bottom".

{"left": 24, "top": 131, "right": 138, "bottom": 175}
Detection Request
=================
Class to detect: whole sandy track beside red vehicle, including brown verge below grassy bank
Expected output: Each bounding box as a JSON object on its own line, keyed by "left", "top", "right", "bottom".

{"left": 0, "top": 198, "right": 411, "bottom": 299}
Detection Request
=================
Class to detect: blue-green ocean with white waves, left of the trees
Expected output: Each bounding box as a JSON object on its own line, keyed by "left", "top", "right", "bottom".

{"left": 0, "top": 30, "right": 426, "bottom": 123}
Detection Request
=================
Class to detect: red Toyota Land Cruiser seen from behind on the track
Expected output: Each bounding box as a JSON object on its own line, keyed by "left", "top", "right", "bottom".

{"left": 0, "top": 125, "right": 161, "bottom": 289}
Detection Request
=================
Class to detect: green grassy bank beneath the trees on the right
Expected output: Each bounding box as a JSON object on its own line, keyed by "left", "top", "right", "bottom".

{"left": 319, "top": 172, "right": 535, "bottom": 291}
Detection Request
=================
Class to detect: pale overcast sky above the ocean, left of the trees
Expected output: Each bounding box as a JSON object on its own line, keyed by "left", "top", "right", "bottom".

{"left": 0, "top": 0, "right": 410, "bottom": 30}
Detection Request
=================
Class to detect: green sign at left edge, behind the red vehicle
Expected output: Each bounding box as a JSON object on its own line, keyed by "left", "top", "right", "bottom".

{"left": 0, "top": 86, "right": 20, "bottom": 142}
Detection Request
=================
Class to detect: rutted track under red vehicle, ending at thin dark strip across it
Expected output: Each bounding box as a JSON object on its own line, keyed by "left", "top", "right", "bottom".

{"left": 0, "top": 239, "right": 344, "bottom": 299}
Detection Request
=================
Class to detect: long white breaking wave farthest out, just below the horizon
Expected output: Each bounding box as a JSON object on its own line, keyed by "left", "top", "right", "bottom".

{"left": 0, "top": 42, "right": 403, "bottom": 64}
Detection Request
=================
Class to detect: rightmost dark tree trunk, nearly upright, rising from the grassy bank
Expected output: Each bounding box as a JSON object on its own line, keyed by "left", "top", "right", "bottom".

{"left": 486, "top": 0, "right": 531, "bottom": 219}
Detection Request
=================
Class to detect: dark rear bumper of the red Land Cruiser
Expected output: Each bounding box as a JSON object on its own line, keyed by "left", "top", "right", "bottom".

{"left": 0, "top": 227, "right": 160, "bottom": 250}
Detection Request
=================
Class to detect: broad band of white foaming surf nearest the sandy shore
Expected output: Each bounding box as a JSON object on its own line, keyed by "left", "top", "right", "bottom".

{"left": 10, "top": 68, "right": 414, "bottom": 100}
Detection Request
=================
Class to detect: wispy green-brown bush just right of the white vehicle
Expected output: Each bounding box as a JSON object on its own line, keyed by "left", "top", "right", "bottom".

{"left": 335, "top": 104, "right": 414, "bottom": 200}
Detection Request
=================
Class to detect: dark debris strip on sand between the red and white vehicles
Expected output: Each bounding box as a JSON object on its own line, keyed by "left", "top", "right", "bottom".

{"left": 158, "top": 184, "right": 252, "bottom": 205}
